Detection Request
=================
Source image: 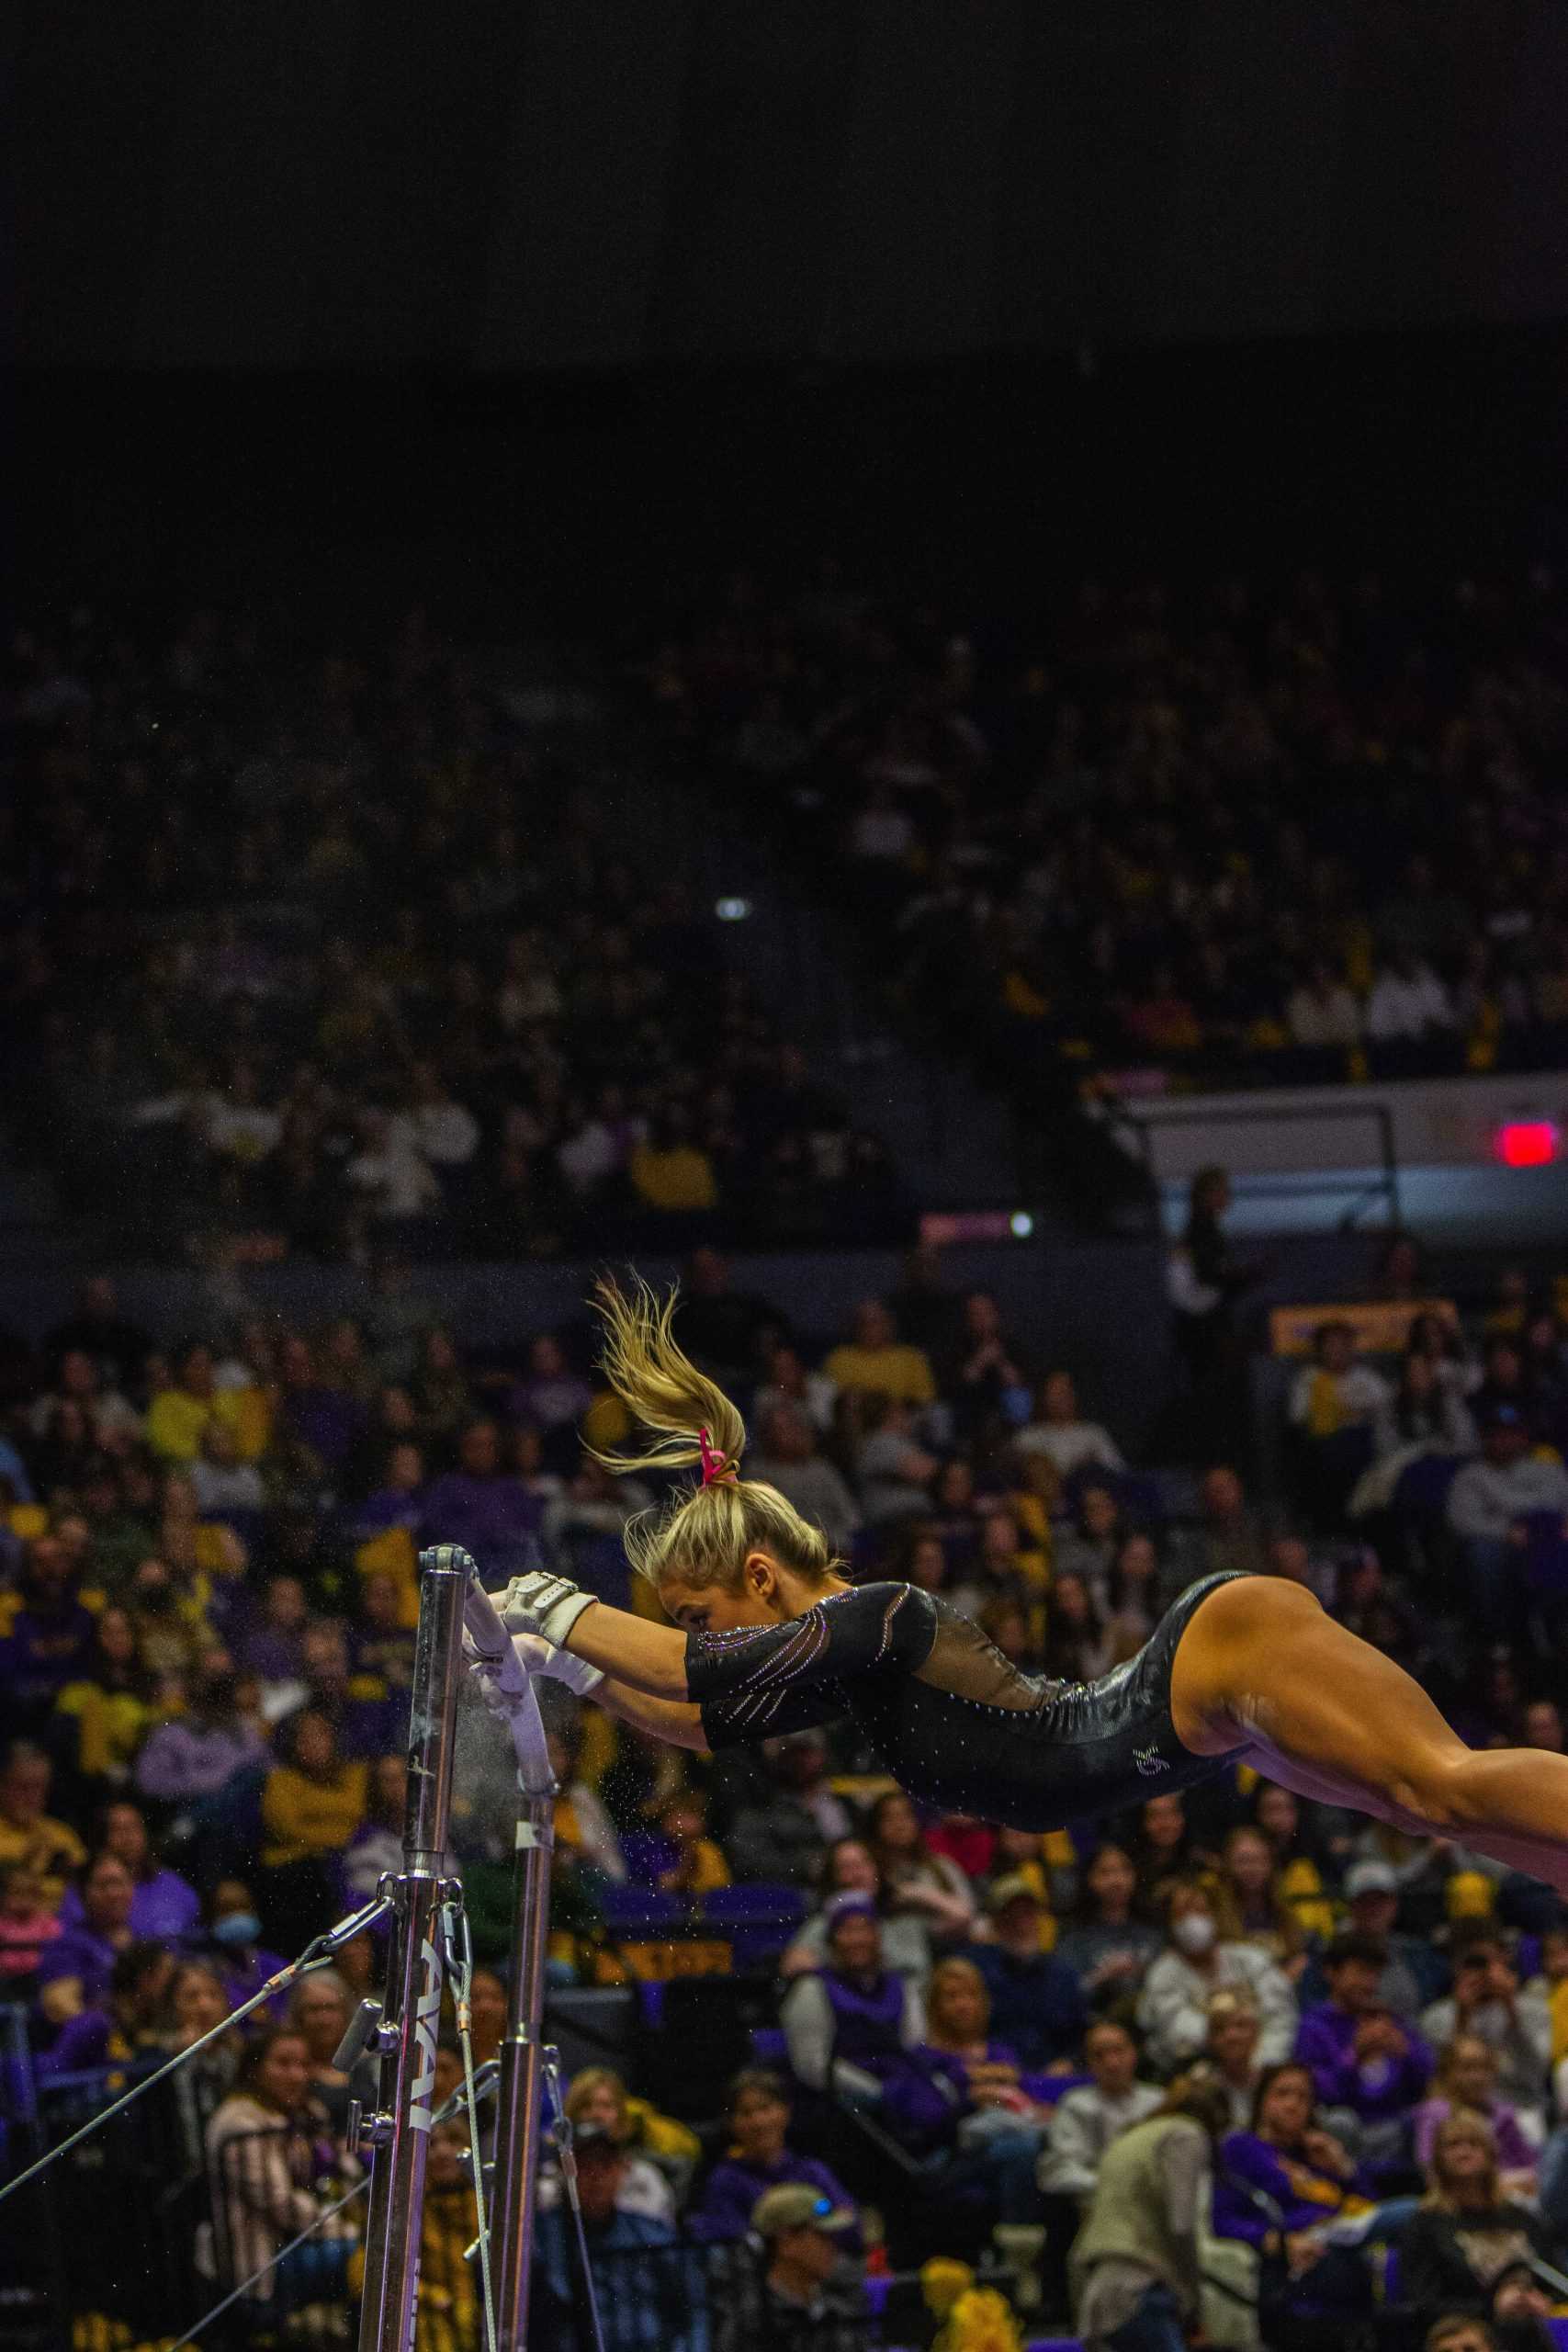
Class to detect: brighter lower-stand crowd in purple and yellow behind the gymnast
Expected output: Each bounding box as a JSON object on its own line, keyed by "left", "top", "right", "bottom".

{"left": 0, "top": 1247, "right": 1568, "bottom": 2352}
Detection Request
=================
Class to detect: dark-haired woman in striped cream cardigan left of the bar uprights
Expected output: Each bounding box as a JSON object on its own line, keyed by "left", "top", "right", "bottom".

{"left": 197, "top": 2025, "right": 355, "bottom": 2312}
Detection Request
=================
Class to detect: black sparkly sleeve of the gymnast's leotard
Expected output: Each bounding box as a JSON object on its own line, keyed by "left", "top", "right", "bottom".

{"left": 686, "top": 1583, "right": 936, "bottom": 1750}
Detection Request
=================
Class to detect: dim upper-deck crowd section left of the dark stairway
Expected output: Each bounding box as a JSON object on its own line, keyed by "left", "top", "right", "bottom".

{"left": 0, "top": 609, "right": 900, "bottom": 1259}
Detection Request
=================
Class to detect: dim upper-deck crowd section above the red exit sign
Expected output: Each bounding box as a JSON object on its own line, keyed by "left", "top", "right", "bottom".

{"left": 637, "top": 564, "right": 1568, "bottom": 1087}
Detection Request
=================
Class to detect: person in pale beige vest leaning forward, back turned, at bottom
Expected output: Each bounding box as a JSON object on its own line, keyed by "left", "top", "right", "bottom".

{"left": 1072, "top": 2075, "right": 1224, "bottom": 2352}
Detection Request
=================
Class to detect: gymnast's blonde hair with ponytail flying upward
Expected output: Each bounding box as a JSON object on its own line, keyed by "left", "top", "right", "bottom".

{"left": 594, "top": 1275, "right": 837, "bottom": 1592}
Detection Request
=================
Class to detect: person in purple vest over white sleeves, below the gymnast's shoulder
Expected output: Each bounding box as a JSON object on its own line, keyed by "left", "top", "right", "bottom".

{"left": 778, "top": 1894, "right": 926, "bottom": 2100}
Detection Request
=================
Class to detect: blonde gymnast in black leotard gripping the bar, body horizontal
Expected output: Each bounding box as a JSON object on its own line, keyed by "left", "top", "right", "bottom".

{"left": 484, "top": 1282, "right": 1568, "bottom": 1894}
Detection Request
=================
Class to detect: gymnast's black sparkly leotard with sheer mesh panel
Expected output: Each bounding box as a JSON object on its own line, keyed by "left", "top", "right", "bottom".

{"left": 686, "top": 1569, "right": 1239, "bottom": 1830}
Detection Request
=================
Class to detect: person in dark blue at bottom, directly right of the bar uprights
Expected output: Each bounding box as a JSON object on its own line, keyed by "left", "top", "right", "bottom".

{"left": 534, "top": 2124, "right": 707, "bottom": 2352}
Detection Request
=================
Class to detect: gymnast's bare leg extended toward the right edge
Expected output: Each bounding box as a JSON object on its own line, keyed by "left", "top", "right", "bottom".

{"left": 1170, "top": 1576, "right": 1568, "bottom": 1895}
